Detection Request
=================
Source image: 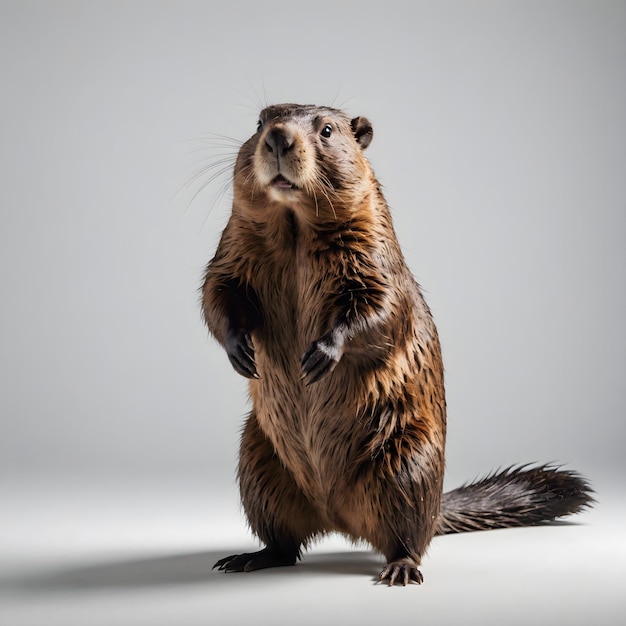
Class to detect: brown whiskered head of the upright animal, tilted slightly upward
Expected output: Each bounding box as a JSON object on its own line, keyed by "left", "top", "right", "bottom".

{"left": 235, "top": 104, "right": 373, "bottom": 219}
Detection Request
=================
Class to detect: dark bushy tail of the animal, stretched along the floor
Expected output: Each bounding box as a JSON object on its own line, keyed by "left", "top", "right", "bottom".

{"left": 437, "top": 465, "right": 594, "bottom": 535}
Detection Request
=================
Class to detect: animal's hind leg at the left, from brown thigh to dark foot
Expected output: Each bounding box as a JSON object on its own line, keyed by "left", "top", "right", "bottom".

{"left": 214, "top": 412, "right": 325, "bottom": 572}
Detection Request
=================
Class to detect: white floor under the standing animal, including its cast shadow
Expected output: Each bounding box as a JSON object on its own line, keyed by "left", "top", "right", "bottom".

{"left": 0, "top": 472, "right": 626, "bottom": 626}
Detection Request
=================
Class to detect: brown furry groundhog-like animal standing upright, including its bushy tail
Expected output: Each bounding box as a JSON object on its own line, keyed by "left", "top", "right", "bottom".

{"left": 202, "top": 104, "right": 591, "bottom": 585}
